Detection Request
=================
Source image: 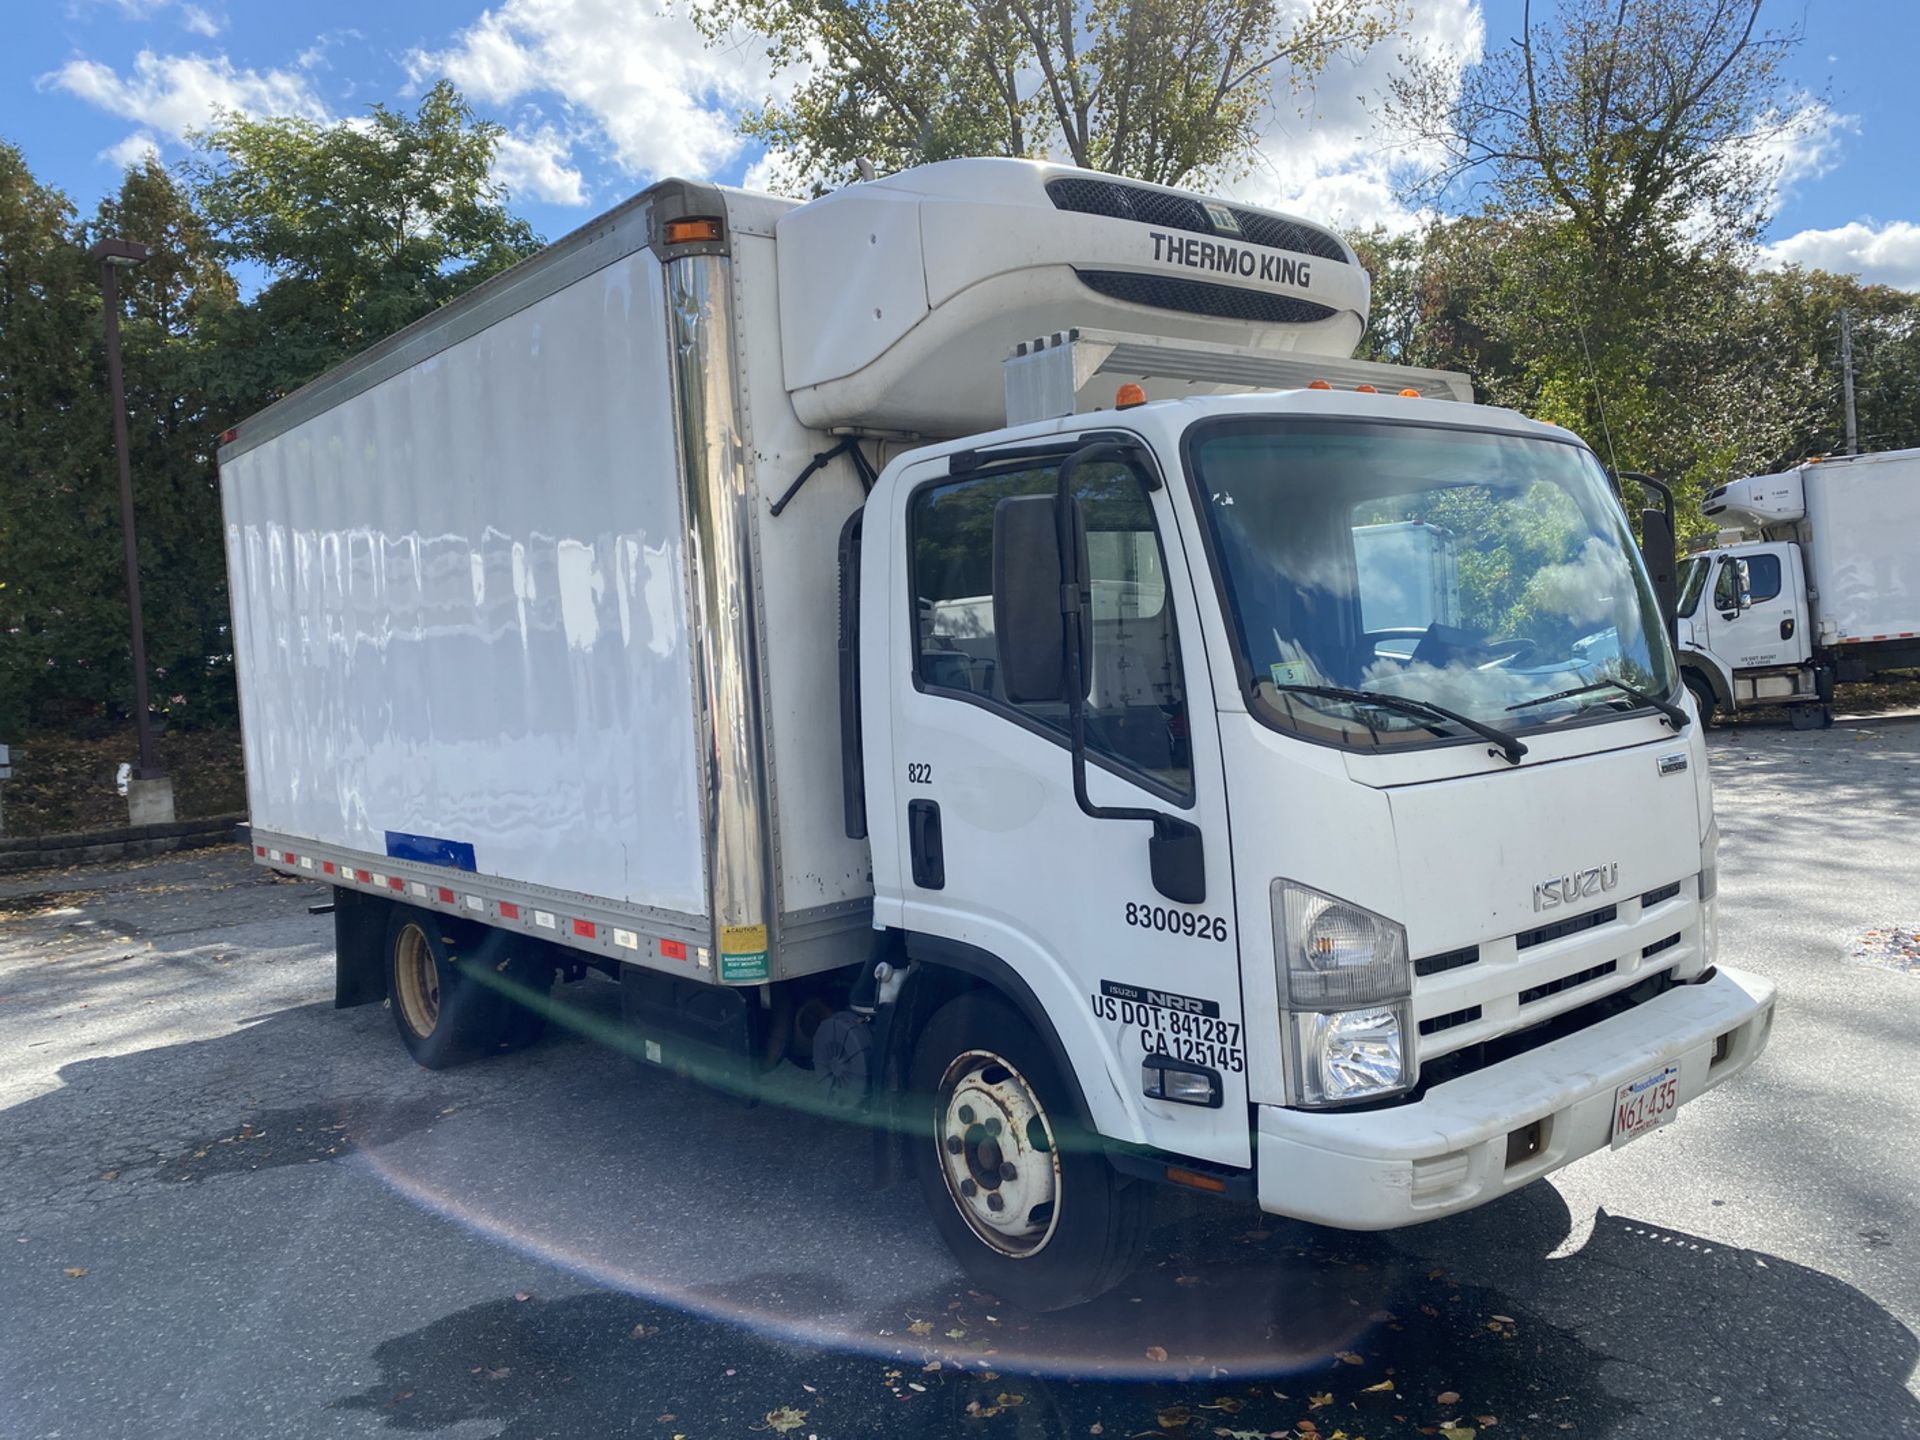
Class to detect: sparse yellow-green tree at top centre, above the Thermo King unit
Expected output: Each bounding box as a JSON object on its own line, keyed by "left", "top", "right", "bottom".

{"left": 693, "top": 0, "right": 1402, "bottom": 192}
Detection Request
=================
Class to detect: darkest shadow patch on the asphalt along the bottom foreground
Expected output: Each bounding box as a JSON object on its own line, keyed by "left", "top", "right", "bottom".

{"left": 334, "top": 1187, "right": 1920, "bottom": 1440}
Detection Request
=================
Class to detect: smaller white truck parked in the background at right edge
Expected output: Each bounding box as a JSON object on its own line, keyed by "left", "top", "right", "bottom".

{"left": 1678, "top": 449, "right": 1920, "bottom": 730}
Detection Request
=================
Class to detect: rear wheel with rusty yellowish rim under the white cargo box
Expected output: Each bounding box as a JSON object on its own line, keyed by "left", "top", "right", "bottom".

{"left": 386, "top": 904, "right": 513, "bottom": 1069}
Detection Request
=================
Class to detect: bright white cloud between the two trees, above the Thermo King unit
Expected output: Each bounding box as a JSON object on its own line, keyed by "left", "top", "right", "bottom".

{"left": 1225, "top": 0, "right": 1486, "bottom": 230}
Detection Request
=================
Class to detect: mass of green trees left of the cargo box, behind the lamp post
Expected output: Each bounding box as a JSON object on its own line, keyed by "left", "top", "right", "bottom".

{"left": 0, "top": 84, "right": 538, "bottom": 737}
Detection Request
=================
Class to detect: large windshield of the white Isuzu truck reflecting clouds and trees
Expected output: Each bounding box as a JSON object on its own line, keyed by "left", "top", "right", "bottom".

{"left": 1190, "top": 420, "right": 1672, "bottom": 747}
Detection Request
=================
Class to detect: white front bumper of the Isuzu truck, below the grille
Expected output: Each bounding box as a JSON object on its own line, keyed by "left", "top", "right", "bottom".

{"left": 1256, "top": 970, "right": 1774, "bottom": 1231}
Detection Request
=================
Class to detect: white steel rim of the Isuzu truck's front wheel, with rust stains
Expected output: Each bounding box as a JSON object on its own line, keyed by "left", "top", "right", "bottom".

{"left": 933, "top": 1050, "right": 1060, "bottom": 1260}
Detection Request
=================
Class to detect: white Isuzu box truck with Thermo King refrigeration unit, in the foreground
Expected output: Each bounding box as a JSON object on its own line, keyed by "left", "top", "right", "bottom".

{"left": 221, "top": 161, "right": 1774, "bottom": 1306}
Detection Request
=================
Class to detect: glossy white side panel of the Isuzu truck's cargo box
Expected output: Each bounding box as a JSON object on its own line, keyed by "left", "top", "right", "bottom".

{"left": 221, "top": 252, "right": 707, "bottom": 914}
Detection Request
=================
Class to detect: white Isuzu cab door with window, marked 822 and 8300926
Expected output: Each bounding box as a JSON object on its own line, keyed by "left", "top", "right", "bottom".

{"left": 876, "top": 443, "right": 1271, "bottom": 1165}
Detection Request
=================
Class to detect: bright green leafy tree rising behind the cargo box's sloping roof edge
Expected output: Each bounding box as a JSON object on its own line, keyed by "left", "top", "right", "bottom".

{"left": 188, "top": 81, "right": 540, "bottom": 403}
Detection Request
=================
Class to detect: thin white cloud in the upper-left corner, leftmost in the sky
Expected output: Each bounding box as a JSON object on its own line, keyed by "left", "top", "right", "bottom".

{"left": 40, "top": 50, "right": 328, "bottom": 140}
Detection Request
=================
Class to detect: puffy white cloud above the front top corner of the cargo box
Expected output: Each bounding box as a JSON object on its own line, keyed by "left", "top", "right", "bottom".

{"left": 407, "top": 0, "right": 791, "bottom": 179}
